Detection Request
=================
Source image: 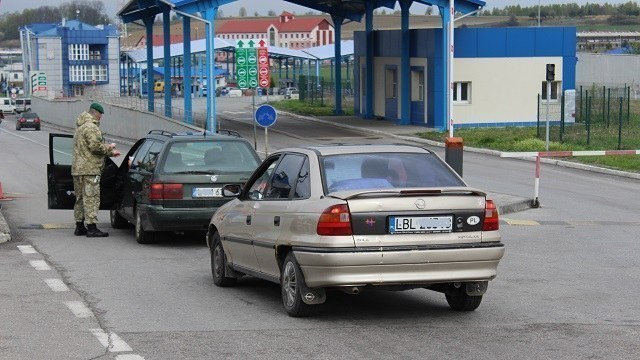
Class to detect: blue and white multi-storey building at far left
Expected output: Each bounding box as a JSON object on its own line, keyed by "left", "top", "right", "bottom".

{"left": 20, "top": 19, "right": 120, "bottom": 98}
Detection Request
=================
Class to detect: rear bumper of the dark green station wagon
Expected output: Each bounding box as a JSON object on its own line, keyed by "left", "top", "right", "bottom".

{"left": 140, "top": 205, "right": 217, "bottom": 231}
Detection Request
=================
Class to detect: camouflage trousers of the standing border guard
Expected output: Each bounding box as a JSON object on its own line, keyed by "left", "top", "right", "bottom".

{"left": 73, "top": 175, "right": 100, "bottom": 224}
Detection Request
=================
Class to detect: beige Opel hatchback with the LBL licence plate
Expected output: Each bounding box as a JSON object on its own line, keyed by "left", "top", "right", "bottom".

{"left": 207, "top": 145, "right": 504, "bottom": 316}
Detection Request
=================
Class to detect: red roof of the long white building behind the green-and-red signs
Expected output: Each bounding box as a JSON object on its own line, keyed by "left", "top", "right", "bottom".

{"left": 216, "top": 17, "right": 326, "bottom": 34}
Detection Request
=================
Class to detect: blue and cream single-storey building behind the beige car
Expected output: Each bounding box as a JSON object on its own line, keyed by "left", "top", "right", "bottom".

{"left": 354, "top": 27, "right": 576, "bottom": 129}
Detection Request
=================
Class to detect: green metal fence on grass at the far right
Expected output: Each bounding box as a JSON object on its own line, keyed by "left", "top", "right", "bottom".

{"left": 537, "top": 85, "right": 640, "bottom": 149}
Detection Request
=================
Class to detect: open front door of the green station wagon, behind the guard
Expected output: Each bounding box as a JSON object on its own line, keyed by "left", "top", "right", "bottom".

{"left": 47, "top": 134, "right": 118, "bottom": 210}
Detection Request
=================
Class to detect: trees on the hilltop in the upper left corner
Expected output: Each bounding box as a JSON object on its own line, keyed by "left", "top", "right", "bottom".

{"left": 0, "top": 0, "right": 112, "bottom": 41}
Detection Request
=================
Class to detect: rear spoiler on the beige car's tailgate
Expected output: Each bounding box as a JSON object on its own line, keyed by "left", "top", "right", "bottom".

{"left": 327, "top": 186, "right": 487, "bottom": 200}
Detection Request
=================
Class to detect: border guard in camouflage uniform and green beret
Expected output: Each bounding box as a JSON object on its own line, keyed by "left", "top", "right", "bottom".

{"left": 71, "top": 103, "right": 120, "bottom": 237}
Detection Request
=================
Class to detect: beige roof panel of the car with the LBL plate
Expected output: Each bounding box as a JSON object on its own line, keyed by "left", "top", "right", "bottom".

{"left": 277, "top": 144, "right": 432, "bottom": 156}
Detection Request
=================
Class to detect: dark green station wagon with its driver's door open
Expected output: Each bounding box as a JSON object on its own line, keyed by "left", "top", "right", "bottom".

{"left": 47, "top": 130, "right": 260, "bottom": 244}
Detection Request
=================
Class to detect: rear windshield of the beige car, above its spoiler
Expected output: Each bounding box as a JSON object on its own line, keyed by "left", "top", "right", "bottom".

{"left": 322, "top": 153, "right": 465, "bottom": 193}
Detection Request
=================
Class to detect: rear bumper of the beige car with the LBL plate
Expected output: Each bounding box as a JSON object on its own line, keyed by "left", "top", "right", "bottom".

{"left": 294, "top": 243, "right": 504, "bottom": 287}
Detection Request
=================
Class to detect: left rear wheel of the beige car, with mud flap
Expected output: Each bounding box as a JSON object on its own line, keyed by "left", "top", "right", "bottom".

{"left": 280, "top": 252, "right": 318, "bottom": 317}
